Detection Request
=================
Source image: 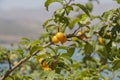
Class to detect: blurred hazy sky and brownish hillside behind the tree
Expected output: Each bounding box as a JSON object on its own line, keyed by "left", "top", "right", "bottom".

{"left": 0, "top": 0, "right": 120, "bottom": 46}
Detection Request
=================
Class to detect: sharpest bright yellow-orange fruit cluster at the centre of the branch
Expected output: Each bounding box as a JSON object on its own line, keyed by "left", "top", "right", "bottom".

{"left": 52, "top": 32, "right": 67, "bottom": 44}
